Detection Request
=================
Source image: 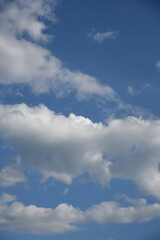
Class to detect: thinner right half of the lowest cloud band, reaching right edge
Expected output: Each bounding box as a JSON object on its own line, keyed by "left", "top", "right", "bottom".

{"left": 85, "top": 202, "right": 160, "bottom": 224}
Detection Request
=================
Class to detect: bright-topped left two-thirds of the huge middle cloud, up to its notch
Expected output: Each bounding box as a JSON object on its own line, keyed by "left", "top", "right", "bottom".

{"left": 0, "top": 104, "right": 109, "bottom": 185}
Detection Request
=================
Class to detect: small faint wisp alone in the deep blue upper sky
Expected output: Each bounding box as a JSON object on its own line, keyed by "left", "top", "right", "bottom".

{"left": 87, "top": 30, "right": 118, "bottom": 43}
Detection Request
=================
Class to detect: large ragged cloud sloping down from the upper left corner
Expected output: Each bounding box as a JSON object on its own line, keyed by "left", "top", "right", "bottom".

{"left": 0, "top": 0, "right": 116, "bottom": 101}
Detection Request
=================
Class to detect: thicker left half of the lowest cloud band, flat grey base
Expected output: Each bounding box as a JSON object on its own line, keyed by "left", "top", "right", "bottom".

{"left": 0, "top": 193, "right": 84, "bottom": 234}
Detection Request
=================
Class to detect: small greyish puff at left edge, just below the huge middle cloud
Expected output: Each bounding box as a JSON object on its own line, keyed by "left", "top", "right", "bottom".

{"left": 0, "top": 166, "right": 26, "bottom": 187}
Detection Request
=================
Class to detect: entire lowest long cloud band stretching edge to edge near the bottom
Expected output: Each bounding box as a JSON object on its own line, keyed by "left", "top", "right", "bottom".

{"left": 0, "top": 194, "right": 160, "bottom": 234}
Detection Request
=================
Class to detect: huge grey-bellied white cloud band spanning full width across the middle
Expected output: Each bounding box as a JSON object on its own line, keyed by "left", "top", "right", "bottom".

{"left": 0, "top": 104, "right": 160, "bottom": 199}
